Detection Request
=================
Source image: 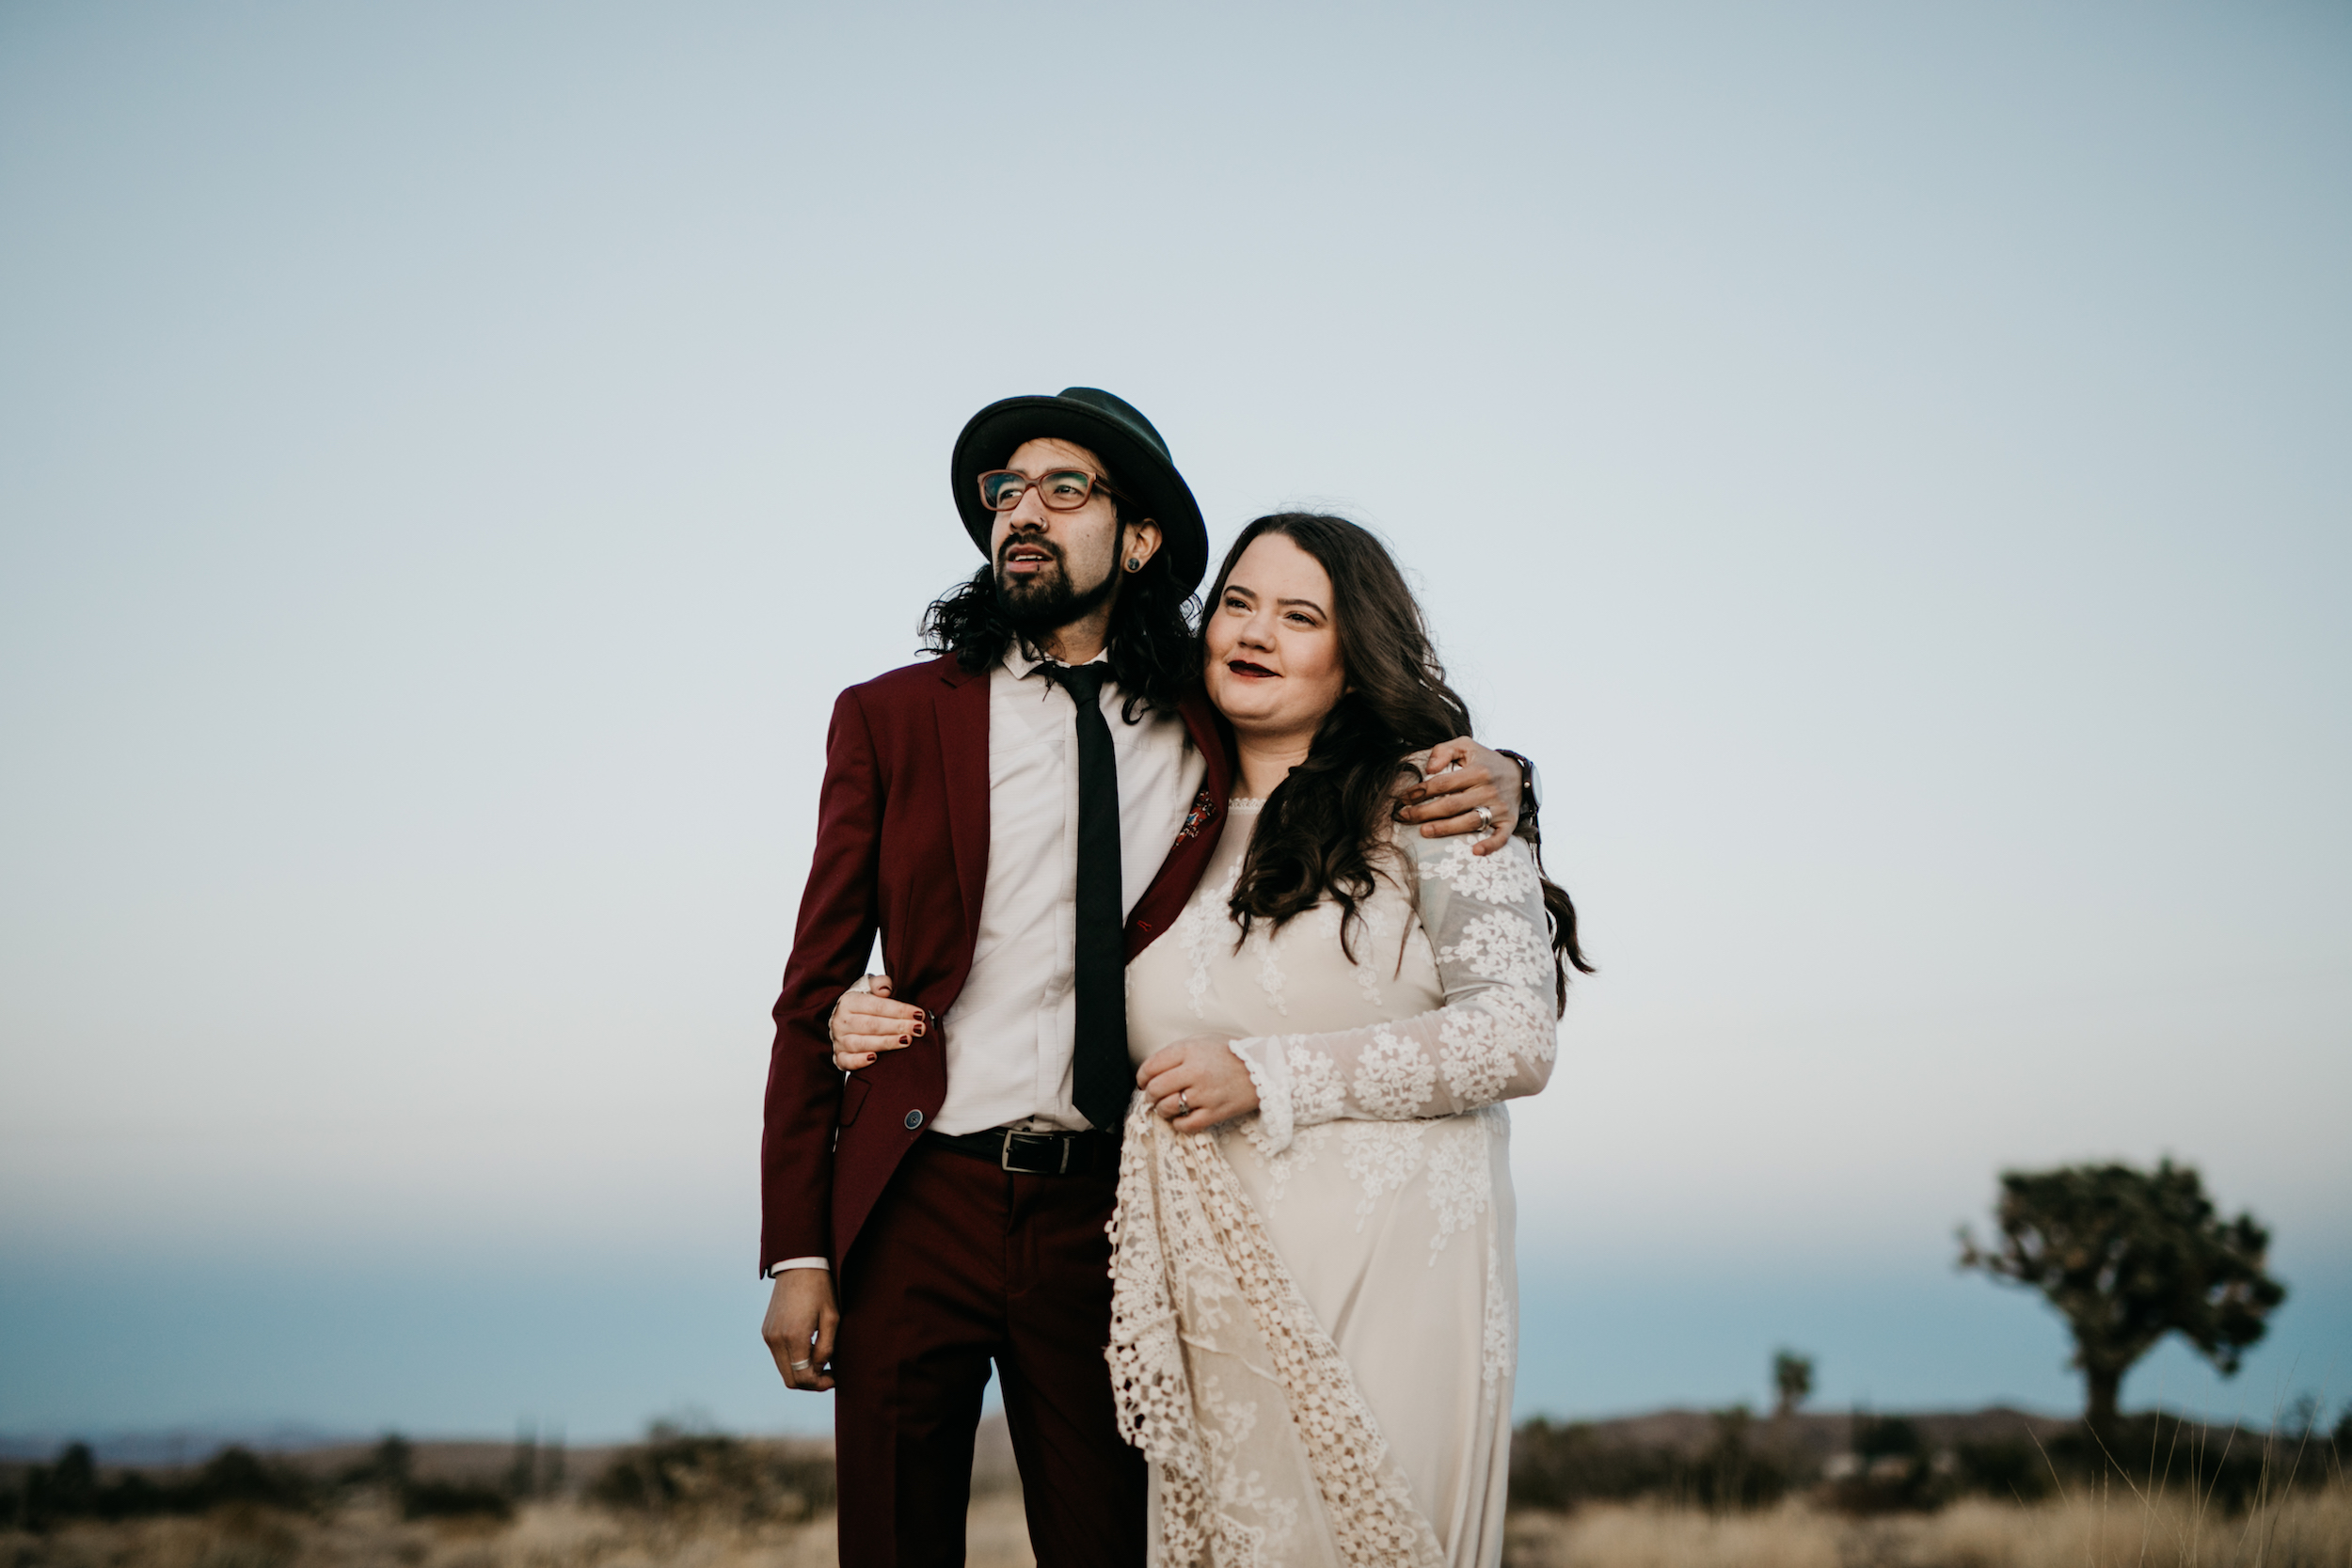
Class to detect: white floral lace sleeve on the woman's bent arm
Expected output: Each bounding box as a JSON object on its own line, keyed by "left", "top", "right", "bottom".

{"left": 1232, "top": 828, "right": 1560, "bottom": 1154}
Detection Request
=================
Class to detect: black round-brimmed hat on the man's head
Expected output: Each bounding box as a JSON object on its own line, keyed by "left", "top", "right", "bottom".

{"left": 950, "top": 386, "right": 1209, "bottom": 593}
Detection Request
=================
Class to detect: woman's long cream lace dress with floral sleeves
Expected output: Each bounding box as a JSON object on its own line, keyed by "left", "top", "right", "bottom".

{"left": 1110, "top": 800, "right": 1557, "bottom": 1568}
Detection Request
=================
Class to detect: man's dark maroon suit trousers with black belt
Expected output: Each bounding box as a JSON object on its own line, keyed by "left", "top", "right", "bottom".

{"left": 833, "top": 1138, "right": 1146, "bottom": 1568}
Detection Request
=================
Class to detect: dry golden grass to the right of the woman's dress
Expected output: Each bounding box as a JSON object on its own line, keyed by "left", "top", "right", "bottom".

{"left": 1505, "top": 1488, "right": 2352, "bottom": 1568}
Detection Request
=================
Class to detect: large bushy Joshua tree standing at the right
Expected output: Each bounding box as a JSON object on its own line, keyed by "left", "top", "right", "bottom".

{"left": 1960, "top": 1159, "right": 2286, "bottom": 1432}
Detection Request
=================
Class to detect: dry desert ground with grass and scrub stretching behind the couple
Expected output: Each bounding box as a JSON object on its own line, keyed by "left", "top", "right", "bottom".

{"left": 0, "top": 1411, "right": 2352, "bottom": 1568}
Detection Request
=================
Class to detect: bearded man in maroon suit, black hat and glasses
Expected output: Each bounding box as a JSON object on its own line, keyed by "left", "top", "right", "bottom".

{"left": 760, "top": 388, "right": 1519, "bottom": 1568}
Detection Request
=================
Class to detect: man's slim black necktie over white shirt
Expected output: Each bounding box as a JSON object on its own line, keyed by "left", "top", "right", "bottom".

{"left": 1044, "top": 665, "right": 1136, "bottom": 1131}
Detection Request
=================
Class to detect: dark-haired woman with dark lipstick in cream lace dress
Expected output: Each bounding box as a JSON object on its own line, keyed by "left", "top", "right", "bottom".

{"left": 1110, "top": 513, "right": 1585, "bottom": 1566}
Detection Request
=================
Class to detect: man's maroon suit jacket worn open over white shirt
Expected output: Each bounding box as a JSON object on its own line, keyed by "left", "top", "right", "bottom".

{"left": 760, "top": 654, "right": 1232, "bottom": 1275}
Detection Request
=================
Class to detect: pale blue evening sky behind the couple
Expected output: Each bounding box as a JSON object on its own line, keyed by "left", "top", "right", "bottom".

{"left": 0, "top": 0, "right": 2352, "bottom": 1434}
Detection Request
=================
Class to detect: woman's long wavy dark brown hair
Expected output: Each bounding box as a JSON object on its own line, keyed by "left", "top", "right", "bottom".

{"left": 1207, "top": 513, "right": 1593, "bottom": 1006}
